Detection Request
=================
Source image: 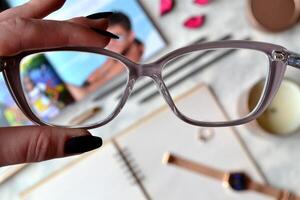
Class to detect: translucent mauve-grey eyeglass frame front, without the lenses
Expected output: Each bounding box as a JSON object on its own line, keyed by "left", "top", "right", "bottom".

{"left": 0, "top": 40, "right": 290, "bottom": 129}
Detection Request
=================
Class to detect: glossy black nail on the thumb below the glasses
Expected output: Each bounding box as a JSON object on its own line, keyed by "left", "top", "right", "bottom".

{"left": 64, "top": 135, "right": 102, "bottom": 154}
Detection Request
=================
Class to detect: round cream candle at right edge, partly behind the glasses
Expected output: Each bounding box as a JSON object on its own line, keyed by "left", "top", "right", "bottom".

{"left": 248, "top": 79, "right": 300, "bottom": 136}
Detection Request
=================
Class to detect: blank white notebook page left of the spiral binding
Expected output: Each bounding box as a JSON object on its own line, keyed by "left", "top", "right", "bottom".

{"left": 21, "top": 143, "right": 143, "bottom": 200}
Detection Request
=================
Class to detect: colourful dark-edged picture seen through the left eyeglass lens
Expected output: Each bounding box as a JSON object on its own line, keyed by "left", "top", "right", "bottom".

{"left": 21, "top": 54, "right": 74, "bottom": 121}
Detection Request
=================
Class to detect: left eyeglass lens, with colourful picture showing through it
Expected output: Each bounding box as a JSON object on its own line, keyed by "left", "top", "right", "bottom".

{"left": 20, "top": 51, "right": 128, "bottom": 126}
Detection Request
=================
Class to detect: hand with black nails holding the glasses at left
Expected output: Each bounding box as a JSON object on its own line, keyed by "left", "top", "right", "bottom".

{"left": 0, "top": 0, "right": 115, "bottom": 166}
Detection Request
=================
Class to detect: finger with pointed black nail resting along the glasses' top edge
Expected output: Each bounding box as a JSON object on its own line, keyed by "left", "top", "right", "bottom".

{"left": 0, "top": 18, "right": 110, "bottom": 56}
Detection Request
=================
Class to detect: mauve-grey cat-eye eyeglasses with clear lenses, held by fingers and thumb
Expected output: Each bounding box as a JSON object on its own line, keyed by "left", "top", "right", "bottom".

{"left": 0, "top": 41, "right": 300, "bottom": 129}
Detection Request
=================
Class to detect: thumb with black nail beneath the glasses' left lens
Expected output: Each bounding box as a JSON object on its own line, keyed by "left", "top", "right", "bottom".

{"left": 0, "top": 126, "right": 102, "bottom": 166}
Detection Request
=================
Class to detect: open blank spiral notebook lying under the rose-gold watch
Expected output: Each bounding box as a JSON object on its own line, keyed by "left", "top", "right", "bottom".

{"left": 20, "top": 85, "right": 270, "bottom": 200}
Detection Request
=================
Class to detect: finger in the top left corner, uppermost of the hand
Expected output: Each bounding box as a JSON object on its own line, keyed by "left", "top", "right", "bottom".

{"left": 0, "top": 0, "right": 66, "bottom": 21}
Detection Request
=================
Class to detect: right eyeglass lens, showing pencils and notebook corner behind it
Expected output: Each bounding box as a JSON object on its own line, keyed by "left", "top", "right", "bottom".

{"left": 162, "top": 49, "right": 269, "bottom": 122}
